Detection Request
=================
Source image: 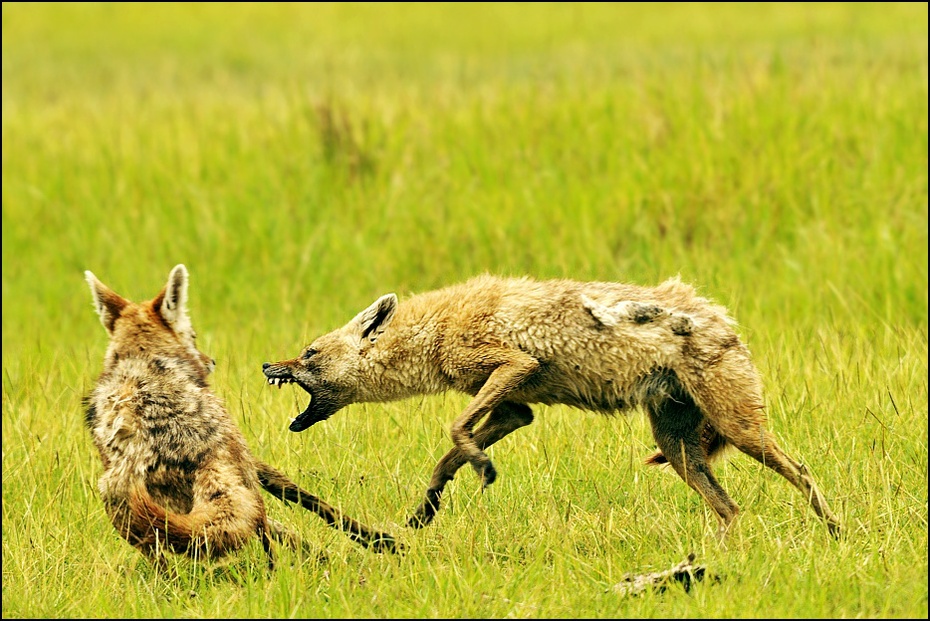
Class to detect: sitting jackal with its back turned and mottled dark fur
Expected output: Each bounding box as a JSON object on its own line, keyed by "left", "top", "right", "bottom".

{"left": 84, "top": 265, "right": 394, "bottom": 568}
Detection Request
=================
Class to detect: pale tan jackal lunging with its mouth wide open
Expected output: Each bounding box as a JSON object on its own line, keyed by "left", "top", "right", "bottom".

{"left": 263, "top": 276, "right": 840, "bottom": 539}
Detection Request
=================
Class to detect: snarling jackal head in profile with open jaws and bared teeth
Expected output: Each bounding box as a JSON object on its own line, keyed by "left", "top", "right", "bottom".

{"left": 262, "top": 293, "right": 397, "bottom": 431}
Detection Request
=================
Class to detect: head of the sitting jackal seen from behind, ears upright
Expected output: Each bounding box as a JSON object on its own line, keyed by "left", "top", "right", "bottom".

{"left": 84, "top": 265, "right": 215, "bottom": 381}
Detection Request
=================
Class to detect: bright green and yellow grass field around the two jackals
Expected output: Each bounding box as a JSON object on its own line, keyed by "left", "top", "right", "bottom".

{"left": 2, "top": 2, "right": 928, "bottom": 618}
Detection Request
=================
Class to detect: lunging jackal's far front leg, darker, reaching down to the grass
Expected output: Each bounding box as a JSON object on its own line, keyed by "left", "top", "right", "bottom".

{"left": 407, "top": 401, "right": 533, "bottom": 528}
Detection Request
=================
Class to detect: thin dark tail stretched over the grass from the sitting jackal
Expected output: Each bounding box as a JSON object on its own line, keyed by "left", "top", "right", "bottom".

{"left": 256, "top": 462, "right": 400, "bottom": 552}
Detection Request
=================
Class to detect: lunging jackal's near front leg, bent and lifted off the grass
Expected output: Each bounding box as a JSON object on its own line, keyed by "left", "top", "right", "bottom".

{"left": 451, "top": 350, "right": 539, "bottom": 489}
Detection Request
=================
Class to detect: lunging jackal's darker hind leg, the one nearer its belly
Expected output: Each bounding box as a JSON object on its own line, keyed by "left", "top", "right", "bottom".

{"left": 648, "top": 395, "right": 739, "bottom": 543}
